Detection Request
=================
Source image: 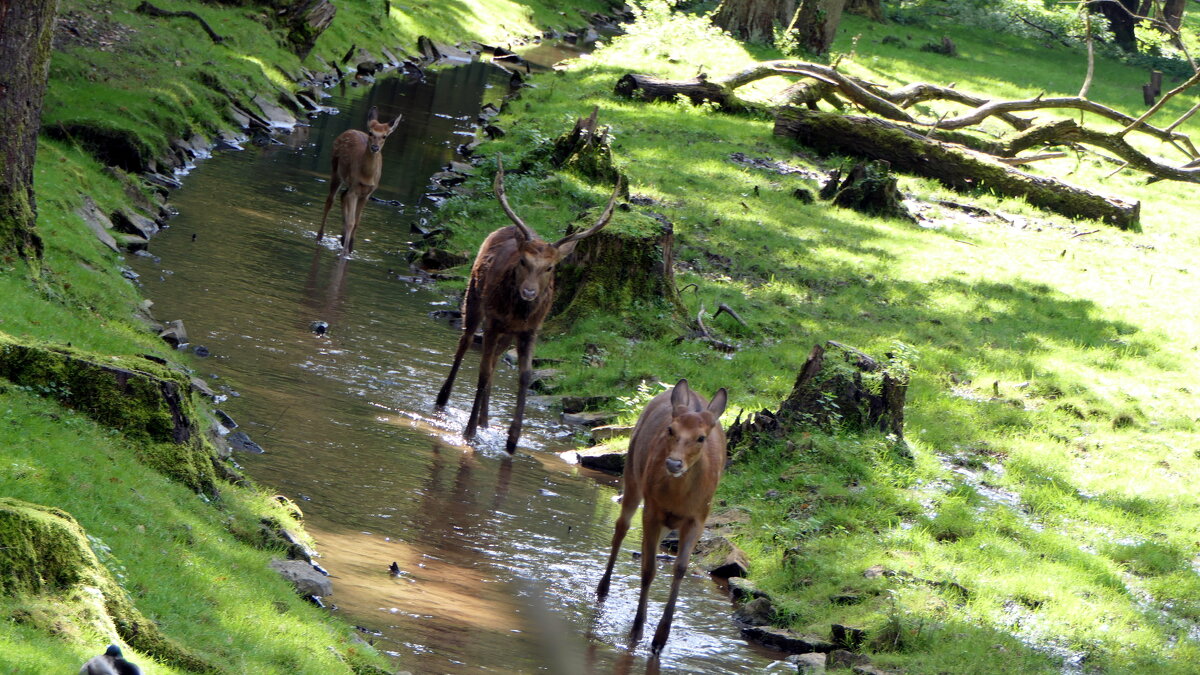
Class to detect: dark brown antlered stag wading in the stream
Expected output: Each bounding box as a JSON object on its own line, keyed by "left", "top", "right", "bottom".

{"left": 436, "top": 156, "right": 622, "bottom": 454}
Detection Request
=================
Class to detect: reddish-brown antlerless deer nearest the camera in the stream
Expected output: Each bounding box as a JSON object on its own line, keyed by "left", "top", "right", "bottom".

{"left": 596, "top": 380, "right": 728, "bottom": 655}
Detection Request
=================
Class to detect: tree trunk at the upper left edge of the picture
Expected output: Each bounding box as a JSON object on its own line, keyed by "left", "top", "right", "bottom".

{"left": 0, "top": 0, "right": 58, "bottom": 258}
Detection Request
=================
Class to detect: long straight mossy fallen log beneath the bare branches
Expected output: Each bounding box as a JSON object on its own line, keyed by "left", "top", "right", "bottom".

{"left": 775, "top": 108, "right": 1141, "bottom": 229}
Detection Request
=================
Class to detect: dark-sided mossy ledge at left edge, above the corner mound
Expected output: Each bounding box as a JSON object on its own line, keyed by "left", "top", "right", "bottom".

{"left": 0, "top": 334, "right": 216, "bottom": 494}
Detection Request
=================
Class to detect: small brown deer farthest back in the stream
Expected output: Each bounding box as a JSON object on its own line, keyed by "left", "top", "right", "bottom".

{"left": 317, "top": 106, "right": 403, "bottom": 255}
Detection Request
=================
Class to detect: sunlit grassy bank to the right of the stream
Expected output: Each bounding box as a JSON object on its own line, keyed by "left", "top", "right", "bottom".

{"left": 442, "top": 2, "right": 1200, "bottom": 673}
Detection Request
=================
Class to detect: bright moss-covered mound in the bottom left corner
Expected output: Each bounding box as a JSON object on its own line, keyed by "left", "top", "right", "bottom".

{"left": 0, "top": 497, "right": 217, "bottom": 673}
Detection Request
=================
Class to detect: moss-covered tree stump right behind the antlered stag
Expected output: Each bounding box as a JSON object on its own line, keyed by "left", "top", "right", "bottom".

{"left": 551, "top": 211, "right": 684, "bottom": 322}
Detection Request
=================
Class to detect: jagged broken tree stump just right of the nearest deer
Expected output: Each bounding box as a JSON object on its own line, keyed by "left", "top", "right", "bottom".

{"left": 726, "top": 341, "right": 908, "bottom": 448}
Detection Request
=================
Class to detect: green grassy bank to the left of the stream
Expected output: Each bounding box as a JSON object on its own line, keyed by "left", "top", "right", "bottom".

{"left": 0, "top": 0, "right": 606, "bottom": 674}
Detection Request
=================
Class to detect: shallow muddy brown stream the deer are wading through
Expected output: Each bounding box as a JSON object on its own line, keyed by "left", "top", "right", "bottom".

{"left": 130, "top": 52, "right": 782, "bottom": 673}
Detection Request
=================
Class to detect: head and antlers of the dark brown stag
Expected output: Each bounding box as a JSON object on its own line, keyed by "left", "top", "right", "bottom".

{"left": 492, "top": 155, "right": 620, "bottom": 303}
